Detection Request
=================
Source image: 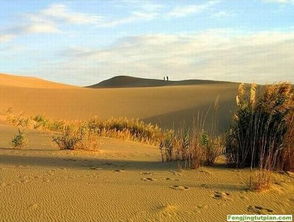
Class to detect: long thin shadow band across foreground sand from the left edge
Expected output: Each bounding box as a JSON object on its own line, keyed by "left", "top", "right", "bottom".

{"left": 0, "top": 151, "right": 176, "bottom": 170}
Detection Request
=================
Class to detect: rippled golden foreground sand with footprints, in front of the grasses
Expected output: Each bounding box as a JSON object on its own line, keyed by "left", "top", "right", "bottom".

{"left": 0, "top": 125, "right": 294, "bottom": 222}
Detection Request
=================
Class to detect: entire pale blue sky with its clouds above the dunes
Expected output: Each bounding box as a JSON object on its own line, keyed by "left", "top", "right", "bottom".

{"left": 0, "top": 0, "right": 294, "bottom": 85}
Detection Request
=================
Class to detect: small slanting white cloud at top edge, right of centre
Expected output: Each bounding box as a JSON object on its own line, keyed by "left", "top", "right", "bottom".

{"left": 167, "top": 1, "right": 219, "bottom": 17}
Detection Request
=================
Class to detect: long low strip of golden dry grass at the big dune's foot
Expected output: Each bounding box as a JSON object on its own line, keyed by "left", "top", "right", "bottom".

{"left": 7, "top": 110, "right": 165, "bottom": 145}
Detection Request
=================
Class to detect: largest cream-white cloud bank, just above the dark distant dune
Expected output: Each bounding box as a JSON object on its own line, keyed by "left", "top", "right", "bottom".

{"left": 48, "top": 30, "right": 294, "bottom": 85}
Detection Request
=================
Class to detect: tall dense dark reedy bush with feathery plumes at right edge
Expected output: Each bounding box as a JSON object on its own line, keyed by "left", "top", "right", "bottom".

{"left": 226, "top": 83, "right": 294, "bottom": 170}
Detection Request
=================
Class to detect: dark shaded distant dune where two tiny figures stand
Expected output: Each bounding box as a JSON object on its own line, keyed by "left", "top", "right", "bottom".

{"left": 88, "top": 76, "right": 232, "bottom": 88}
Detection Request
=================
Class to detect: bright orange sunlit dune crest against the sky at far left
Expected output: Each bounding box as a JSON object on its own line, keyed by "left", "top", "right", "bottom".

{"left": 0, "top": 73, "right": 73, "bottom": 89}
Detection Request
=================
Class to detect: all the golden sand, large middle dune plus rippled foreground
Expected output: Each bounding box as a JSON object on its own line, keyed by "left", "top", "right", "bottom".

{"left": 0, "top": 73, "right": 294, "bottom": 222}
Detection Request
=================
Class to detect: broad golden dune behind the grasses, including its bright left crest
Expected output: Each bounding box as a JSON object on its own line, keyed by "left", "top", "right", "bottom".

{"left": 0, "top": 75, "right": 237, "bottom": 131}
